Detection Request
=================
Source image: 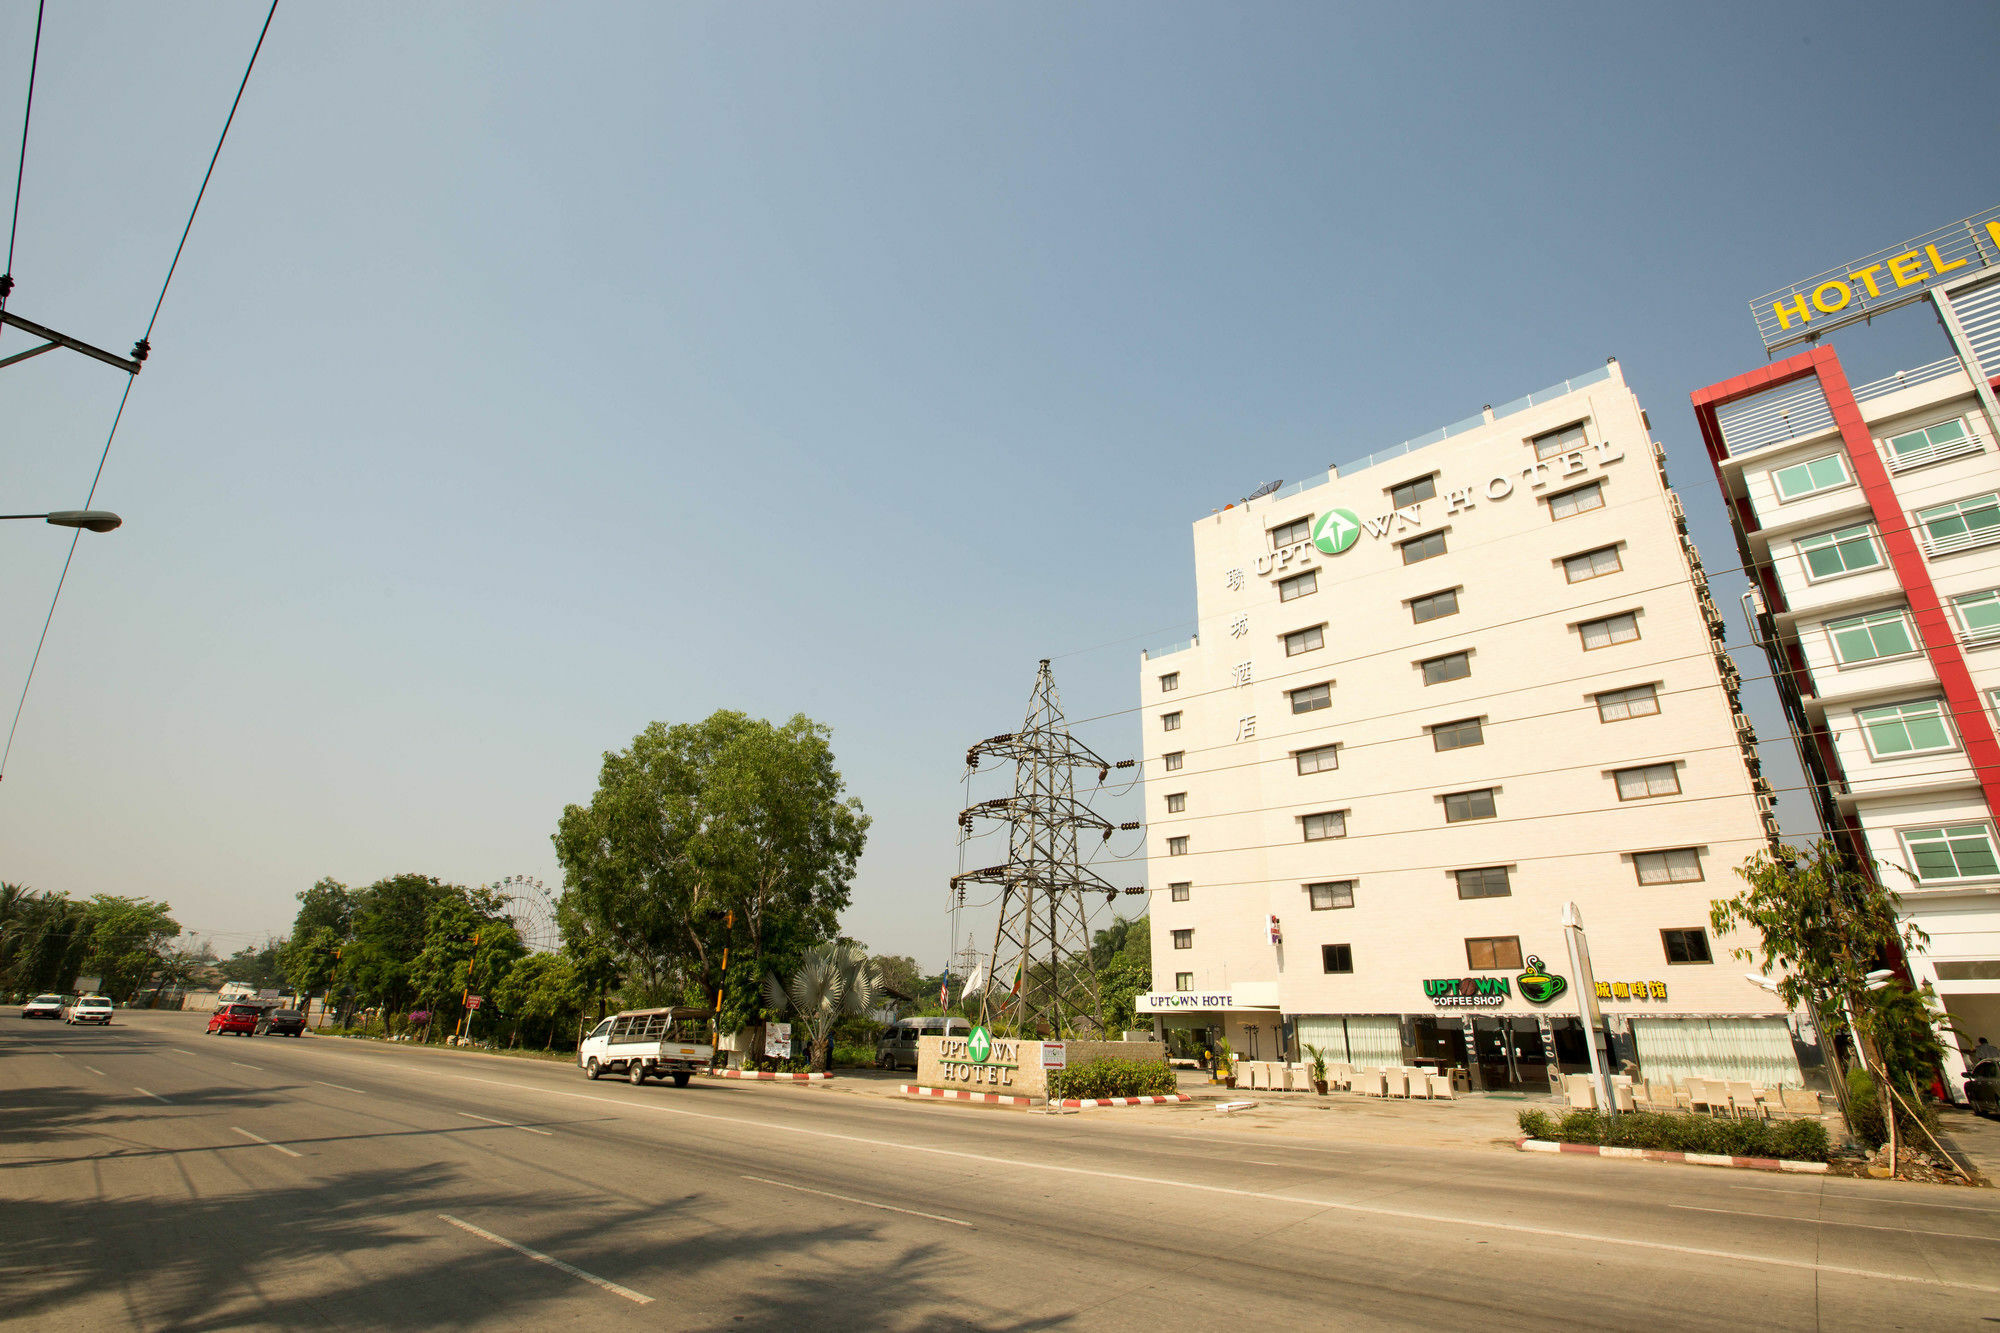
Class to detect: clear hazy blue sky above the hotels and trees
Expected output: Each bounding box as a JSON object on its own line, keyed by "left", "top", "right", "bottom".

{"left": 0, "top": 0, "right": 2000, "bottom": 971}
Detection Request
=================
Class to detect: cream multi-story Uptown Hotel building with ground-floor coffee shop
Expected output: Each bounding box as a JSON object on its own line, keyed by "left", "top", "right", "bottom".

{"left": 1140, "top": 362, "right": 1816, "bottom": 1091}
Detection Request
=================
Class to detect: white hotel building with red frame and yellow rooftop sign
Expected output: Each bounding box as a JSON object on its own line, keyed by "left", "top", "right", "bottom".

{"left": 1694, "top": 236, "right": 2000, "bottom": 1099}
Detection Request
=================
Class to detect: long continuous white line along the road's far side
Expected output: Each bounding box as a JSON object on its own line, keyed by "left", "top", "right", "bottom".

{"left": 410, "top": 1071, "right": 2000, "bottom": 1295}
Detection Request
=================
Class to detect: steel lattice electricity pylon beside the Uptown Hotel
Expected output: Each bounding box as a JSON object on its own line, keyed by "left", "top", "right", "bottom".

{"left": 952, "top": 658, "right": 1144, "bottom": 1035}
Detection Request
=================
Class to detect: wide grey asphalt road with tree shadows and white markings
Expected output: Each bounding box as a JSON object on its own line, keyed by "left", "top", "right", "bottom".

{"left": 0, "top": 1011, "right": 2000, "bottom": 1333}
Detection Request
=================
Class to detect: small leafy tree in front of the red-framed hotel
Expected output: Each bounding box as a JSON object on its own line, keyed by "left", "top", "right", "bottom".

{"left": 1708, "top": 839, "right": 1930, "bottom": 1167}
